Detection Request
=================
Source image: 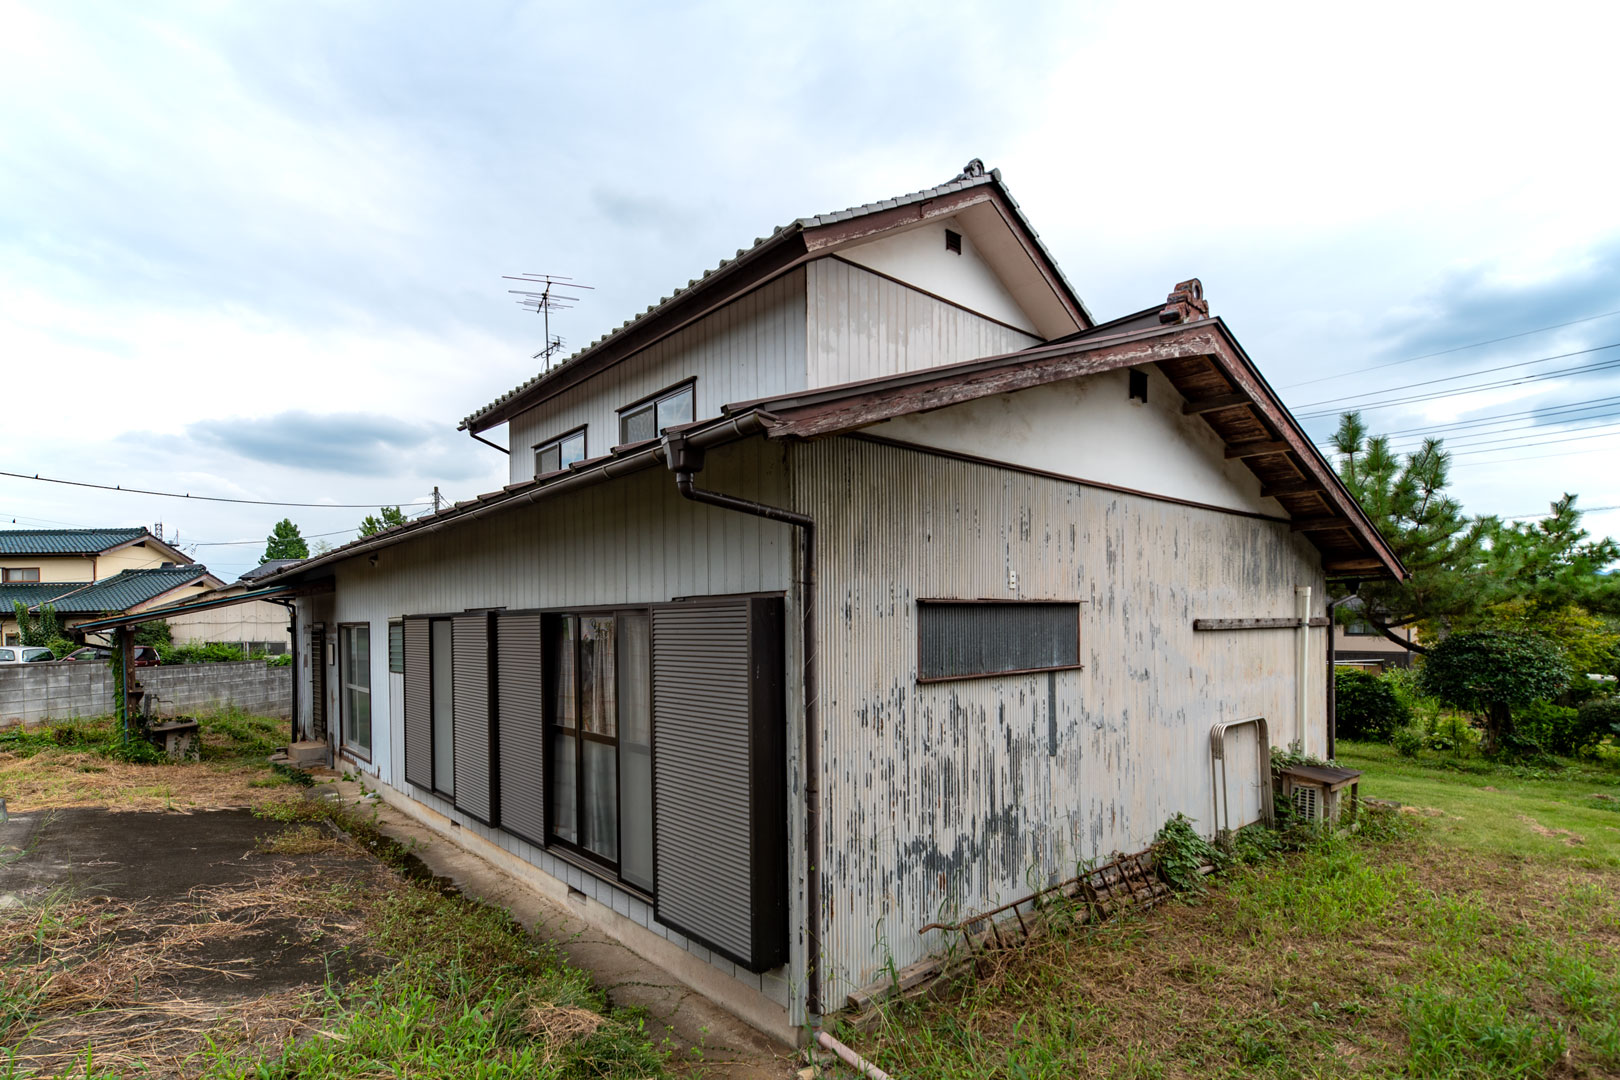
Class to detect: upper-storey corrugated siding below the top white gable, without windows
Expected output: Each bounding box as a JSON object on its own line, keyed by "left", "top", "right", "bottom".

{"left": 805, "top": 259, "right": 1040, "bottom": 387}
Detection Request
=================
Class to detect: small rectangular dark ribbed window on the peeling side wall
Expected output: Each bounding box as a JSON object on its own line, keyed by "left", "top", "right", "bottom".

{"left": 917, "top": 601, "right": 1081, "bottom": 682}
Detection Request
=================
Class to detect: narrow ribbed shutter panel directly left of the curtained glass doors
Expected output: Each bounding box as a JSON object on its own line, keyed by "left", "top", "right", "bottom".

{"left": 496, "top": 615, "right": 546, "bottom": 844}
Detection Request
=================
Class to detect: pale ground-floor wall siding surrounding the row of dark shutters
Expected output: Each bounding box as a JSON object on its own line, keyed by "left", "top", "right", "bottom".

{"left": 298, "top": 440, "right": 804, "bottom": 1023}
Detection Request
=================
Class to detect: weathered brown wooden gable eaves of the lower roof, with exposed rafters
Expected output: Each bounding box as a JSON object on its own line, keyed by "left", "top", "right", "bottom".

{"left": 745, "top": 319, "right": 1406, "bottom": 576}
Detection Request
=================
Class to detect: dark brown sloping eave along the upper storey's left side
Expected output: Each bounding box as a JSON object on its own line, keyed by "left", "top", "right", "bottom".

{"left": 469, "top": 227, "right": 808, "bottom": 434}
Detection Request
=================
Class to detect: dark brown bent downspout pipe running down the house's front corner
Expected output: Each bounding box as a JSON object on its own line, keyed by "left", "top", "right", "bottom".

{"left": 663, "top": 421, "right": 821, "bottom": 1017}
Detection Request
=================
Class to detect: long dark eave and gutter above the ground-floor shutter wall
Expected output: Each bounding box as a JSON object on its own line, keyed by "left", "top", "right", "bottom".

{"left": 262, "top": 413, "right": 765, "bottom": 585}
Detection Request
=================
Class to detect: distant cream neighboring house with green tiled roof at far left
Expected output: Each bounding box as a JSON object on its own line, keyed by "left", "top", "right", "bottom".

{"left": 0, "top": 528, "right": 208, "bottom": 641}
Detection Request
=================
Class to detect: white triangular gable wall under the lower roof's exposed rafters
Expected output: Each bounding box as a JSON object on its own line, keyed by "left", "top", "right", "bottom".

{"left": 865, "top": 369, "right": 1288, "bottom": 518}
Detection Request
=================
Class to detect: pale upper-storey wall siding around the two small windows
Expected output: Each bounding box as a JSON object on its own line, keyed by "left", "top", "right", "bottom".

{"left": 509, "top": 270, "right": 805, "bottom": 483}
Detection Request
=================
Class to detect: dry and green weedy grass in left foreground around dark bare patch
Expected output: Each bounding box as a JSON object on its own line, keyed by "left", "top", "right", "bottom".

{"left": 0, "top": 801, "right": 664, "bottom": 1080}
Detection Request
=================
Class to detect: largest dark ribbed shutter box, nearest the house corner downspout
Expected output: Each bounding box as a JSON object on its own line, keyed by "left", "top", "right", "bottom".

{"left": 653, "top": 599, "right": 787, "bottom": 972}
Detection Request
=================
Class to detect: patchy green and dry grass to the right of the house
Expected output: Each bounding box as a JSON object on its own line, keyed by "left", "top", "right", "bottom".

{"left": 846, "top": 786, "right": 1620, "bottom": 1080}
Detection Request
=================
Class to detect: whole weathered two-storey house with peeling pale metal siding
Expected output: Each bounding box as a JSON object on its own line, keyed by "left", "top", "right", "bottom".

{"left": 266, "top": 162, "right": 1403, "bottom": 1038}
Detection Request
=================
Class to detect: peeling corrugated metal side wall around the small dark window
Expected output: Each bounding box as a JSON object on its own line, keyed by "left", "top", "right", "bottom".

{"left": 794, "top": 439, "right": 1324, "bottom": 1001}
